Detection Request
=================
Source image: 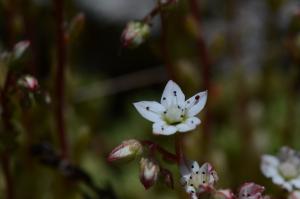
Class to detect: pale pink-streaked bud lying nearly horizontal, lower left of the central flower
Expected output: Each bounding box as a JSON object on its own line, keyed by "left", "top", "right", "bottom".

{"left": 107, "top": 139, "right": 143, "bottom": 162}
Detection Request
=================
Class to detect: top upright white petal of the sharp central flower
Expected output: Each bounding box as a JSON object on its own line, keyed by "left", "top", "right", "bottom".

{"left": 161, "top": 80, "right": 185, "bottom": 108}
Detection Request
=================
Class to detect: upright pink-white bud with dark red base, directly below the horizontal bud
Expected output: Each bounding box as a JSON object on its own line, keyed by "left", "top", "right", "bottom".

{"left": 140, "top": 158, "right": 160, "bottom": 189}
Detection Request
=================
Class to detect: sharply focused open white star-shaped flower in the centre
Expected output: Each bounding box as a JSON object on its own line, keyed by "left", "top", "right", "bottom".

{"left": 134, "top": 80, "right": 207, "bottom": 135}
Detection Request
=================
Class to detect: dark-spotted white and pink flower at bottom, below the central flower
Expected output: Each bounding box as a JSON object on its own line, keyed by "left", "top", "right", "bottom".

{"left": 180, "top": 161, "right": 218, "bottom": 199}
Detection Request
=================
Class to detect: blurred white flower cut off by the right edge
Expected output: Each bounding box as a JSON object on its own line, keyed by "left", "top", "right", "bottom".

{"left": 261, "top": 147, "right": 300, "bottom": 192}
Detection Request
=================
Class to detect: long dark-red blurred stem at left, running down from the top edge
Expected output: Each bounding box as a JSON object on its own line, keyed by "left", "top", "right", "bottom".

{"left": 53, "top": 0, "right": 68, "bottom": 158}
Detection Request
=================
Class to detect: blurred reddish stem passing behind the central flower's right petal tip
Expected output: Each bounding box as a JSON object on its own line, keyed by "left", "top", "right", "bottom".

{"left": 190, "top": 0, "right": 212, "bottom": 152}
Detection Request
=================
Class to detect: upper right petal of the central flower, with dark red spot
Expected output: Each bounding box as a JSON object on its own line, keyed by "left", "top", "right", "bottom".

{"left": 185, "top": 91, "right": 207, "bottom": 116}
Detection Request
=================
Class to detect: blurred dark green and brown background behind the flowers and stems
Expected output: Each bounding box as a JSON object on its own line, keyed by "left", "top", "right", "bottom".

{"left": 0, "top": 0, "right": 300, "bottom": 199}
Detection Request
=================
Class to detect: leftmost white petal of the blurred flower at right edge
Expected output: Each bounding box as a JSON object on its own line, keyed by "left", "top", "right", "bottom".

{"left": 261, "top": 155, "right": 279, "bottom": 177}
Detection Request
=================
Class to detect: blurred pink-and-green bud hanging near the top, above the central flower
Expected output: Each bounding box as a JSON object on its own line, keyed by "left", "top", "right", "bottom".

{"left": 121, "top": 21, "right": 150, "bottom": 48}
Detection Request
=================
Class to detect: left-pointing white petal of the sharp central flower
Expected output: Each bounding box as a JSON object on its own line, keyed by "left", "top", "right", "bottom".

{"left": 133, "top": 101, "right": 165, "bottom": 122}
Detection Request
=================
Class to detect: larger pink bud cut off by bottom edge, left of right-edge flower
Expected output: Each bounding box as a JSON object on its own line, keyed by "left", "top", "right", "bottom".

{"left": 239, "top": 182, "right": 265, "bottom": 199}
